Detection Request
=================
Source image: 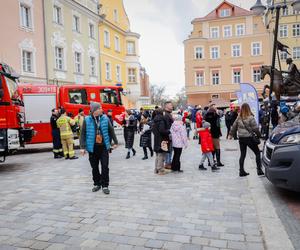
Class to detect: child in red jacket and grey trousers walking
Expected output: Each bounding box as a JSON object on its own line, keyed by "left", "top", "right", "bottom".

{"left": 198, "top": 121, "right": 220, "bottom": 171}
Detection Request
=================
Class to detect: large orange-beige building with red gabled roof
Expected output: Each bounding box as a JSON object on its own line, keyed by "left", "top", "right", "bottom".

{"left": 184, "top": 1, "right": 271, "bottom": 106}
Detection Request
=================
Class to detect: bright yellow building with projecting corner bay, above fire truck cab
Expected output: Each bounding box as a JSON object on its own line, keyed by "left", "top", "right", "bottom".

{"left": 99, "top": 0, "right": 141, "bottom": 108}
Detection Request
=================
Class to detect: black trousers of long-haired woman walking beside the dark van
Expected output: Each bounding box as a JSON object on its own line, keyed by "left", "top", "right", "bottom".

{"left": 239, "top": 137, "right": 261, "bottom": 171}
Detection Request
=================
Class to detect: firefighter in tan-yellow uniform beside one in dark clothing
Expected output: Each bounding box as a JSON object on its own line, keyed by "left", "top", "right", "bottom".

{"left": 56, "top": 109, "right": 78, "bottom": 160}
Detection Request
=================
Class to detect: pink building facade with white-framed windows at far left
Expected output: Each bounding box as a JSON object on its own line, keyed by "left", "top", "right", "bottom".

{"left": 0, "top": 0, "right": 47, "bottom": 83}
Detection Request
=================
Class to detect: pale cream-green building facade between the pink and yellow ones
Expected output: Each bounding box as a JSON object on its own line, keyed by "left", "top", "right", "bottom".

{"left": 44, "top": 0, "right": 100, "bottom": 85}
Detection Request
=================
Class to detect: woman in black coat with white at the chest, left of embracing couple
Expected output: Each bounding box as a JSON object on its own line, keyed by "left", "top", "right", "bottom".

{"left": 140, "top": 113, "right": 153, "bottom": 160}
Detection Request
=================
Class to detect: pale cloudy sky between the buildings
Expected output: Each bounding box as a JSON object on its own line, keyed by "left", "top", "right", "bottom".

{"left": 123, "top": 0, "right": 256, "bottom": 96}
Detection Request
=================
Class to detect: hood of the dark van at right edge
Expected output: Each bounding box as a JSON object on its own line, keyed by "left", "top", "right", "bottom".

{"left": 270, "top": 115, "right": 300, "bottom": 144}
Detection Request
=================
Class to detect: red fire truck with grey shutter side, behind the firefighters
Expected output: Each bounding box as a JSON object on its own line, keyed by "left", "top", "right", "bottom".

{"left": 19, "top": 84, "right": 125, "bottom": 143}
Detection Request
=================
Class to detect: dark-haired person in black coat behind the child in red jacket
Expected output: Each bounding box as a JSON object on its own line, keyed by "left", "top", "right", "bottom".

{"left": 205, "top": 104, "right": 224, "bottom": 167}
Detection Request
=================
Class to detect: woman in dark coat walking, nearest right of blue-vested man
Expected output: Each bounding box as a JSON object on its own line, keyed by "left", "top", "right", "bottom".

{"left": 123, "top": 110, "right": 137, "bottom": 159}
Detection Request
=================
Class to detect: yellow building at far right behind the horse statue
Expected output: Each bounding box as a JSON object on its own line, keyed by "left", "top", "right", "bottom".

{"left": 265, "top": 0, "right": 300, "bottom": 70}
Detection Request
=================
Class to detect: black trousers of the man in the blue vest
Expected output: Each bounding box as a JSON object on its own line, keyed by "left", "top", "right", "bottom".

{"left": 89, "top": 144, "right": 109, "bottom": 187}
